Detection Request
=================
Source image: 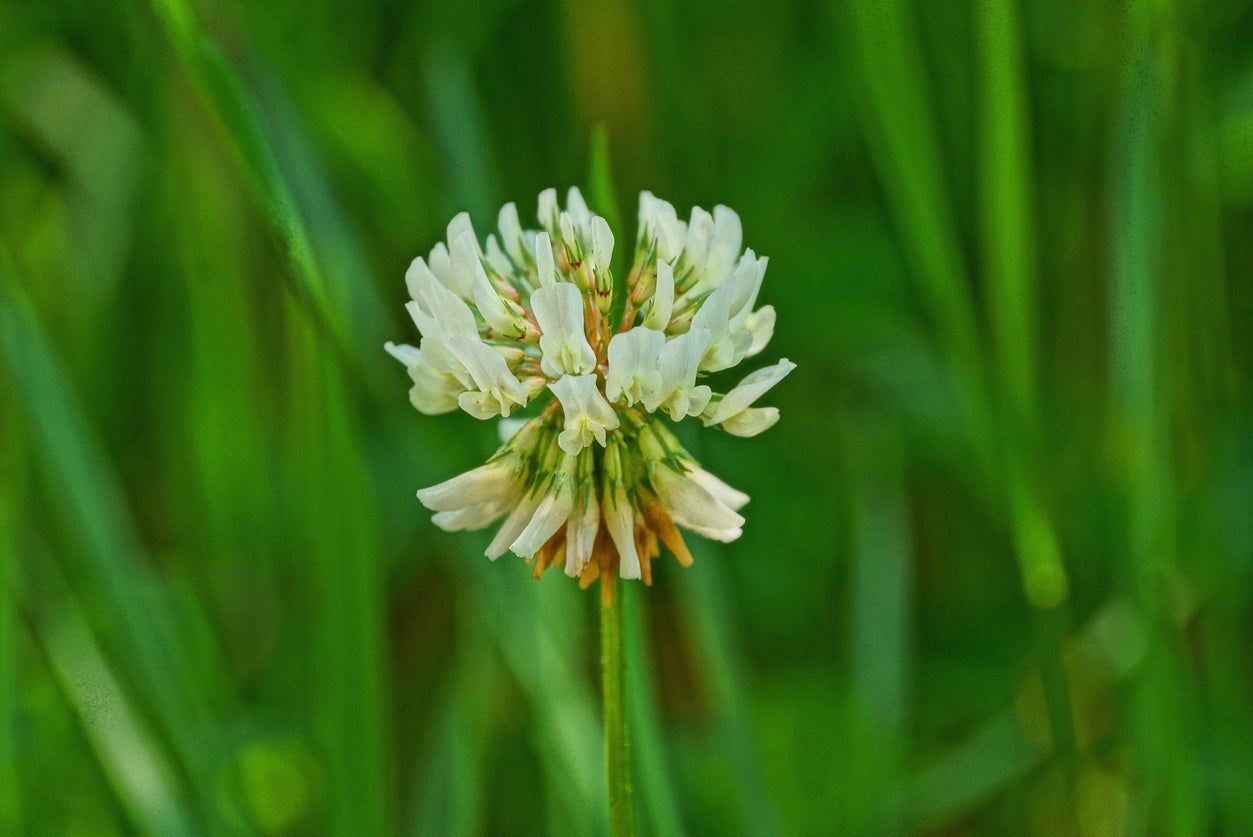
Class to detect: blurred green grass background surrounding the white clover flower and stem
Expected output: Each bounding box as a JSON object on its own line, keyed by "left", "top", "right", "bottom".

{"left": 0, "top": 0, "right": 1253, "bottom": 834}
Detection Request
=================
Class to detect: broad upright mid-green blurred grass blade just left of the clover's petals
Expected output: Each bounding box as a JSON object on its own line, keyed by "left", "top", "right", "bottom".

{"left": 287, "top": 311, "right": 391, "bottom": 836}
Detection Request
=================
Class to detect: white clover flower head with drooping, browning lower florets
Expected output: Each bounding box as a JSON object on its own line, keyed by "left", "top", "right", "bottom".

{"left": 386, "top": 188, "right": 796, "bottom": 596}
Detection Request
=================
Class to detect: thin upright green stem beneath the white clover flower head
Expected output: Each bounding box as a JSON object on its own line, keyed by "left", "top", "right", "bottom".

{"left": 600, "top": 590, "right": 635, "bottom": 837}
